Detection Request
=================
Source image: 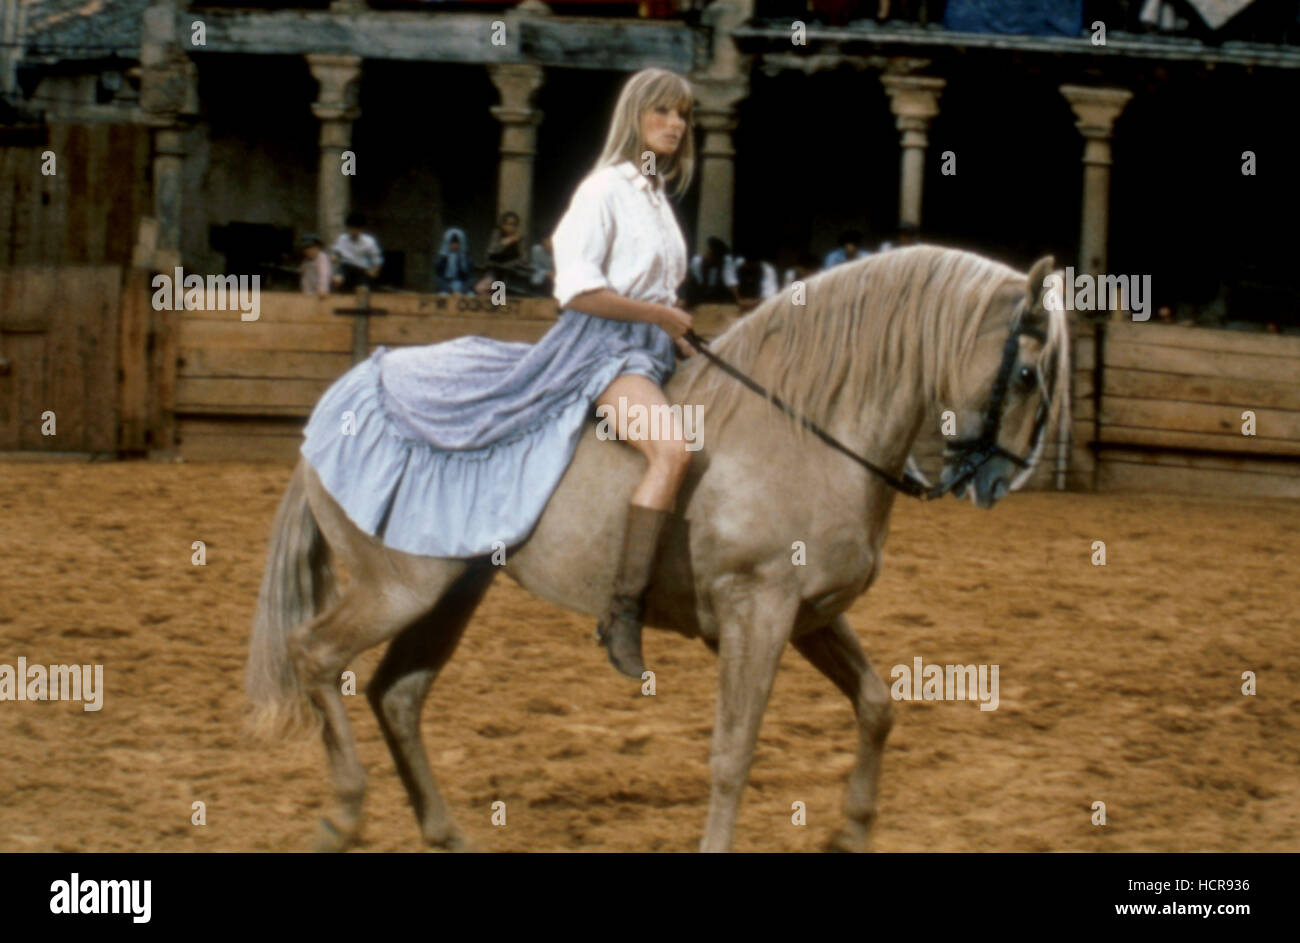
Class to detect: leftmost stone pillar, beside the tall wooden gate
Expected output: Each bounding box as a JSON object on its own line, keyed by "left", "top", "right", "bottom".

{"left": 139, "top": 3, "right": 199, "bottom": 271}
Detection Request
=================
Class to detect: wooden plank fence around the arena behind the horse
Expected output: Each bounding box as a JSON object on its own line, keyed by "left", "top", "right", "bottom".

{"left": 0, "top": 267, "right": 1300, "bottom": 497}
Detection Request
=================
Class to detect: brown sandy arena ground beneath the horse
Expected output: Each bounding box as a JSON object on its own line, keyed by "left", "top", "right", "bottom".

{"left": 0, "top": 462, "right": 1300, "bottom": 852}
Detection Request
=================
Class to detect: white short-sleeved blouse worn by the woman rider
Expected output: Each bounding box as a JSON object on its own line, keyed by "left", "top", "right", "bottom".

{"left": 551, "top": 160, "right": 686, "bottom": 310}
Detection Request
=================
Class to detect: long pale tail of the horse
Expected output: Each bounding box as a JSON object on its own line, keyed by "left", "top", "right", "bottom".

{"left": 244, "top": 462, "right": 335, "bottom": 740}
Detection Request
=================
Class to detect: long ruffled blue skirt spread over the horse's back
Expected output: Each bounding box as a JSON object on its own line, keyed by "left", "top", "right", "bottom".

{"left": 302, "top": 311, "right": 676, "bottom": 557}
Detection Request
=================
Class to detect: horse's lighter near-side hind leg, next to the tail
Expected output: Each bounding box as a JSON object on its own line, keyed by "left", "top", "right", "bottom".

{"left": 289, "top": 567, "right": 473, "bottom": 852}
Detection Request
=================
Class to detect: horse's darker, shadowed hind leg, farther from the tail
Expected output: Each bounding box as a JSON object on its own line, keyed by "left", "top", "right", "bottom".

{"left": 367, "top": 566, "right": 497, "bottom": 851}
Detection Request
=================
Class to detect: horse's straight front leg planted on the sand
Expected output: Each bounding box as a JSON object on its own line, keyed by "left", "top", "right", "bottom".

{"left": 699, "top": 575, "right": 798, "bottom": 852}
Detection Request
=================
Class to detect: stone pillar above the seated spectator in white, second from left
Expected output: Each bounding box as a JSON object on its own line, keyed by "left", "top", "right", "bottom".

{"left": 307, "top": 52, "right": 361, "bottom": 247}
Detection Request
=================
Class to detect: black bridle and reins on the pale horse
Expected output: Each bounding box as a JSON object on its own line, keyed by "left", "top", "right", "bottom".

{"left": 683, "top": 307, "right": 1056, "bottom": 501}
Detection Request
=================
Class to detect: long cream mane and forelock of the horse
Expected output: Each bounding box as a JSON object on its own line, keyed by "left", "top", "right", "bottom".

{"left": 675, "top": 246, "right": 1069, "bottom": 447}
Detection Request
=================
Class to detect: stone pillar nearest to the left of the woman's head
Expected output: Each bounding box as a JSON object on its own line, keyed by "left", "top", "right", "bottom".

{"left": 488, "top": 62, "right": 546, "bottom": 239}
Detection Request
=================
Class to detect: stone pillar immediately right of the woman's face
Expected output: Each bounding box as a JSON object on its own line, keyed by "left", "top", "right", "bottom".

{"left": 690, "top": 75, "right": 749, "bottom": 251}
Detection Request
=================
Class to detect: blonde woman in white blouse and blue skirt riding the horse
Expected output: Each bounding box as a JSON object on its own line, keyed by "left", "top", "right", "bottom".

{"left": 303, "top": 69, "right": 694, "bottom": 679}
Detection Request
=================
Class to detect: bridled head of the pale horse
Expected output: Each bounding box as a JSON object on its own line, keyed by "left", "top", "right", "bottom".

{"left": 940, "top": 256, "right": 1069, "bottom": 507}
